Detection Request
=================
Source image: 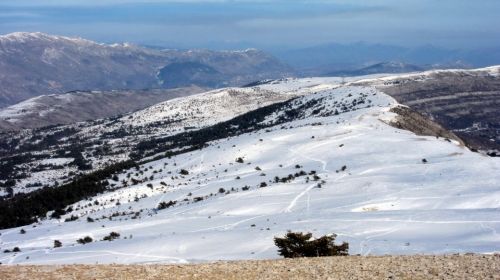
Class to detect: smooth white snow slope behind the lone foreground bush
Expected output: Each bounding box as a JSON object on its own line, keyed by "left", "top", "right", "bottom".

{"left": 0, "top": 87, "right": 500, "bottom": 264}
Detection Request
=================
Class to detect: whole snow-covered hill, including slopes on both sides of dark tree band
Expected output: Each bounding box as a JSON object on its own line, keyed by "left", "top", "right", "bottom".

{"left": 0, "top": 78, "right": 500, "bottom": 264}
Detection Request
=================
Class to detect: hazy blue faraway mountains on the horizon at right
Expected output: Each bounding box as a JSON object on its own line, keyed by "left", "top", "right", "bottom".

{"left": 273, "top": 42, "right": 500, "bottom": 76}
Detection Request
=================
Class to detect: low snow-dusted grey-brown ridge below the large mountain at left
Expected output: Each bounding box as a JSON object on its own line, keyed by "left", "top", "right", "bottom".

{"left": 0, "top": 86, "right": 204, "bottom": 131}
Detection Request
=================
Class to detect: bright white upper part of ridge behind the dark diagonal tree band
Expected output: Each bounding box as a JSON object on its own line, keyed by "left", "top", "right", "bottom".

{"left": 83, "top": 78, "right": 339, "bottom": 135}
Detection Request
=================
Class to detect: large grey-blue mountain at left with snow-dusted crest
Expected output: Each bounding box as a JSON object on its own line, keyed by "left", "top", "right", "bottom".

{"left": 0, "top": 32, "right": 292, "bottom": 107}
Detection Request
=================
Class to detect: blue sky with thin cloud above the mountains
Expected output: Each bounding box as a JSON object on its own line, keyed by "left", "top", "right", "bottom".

{"left": 0, "top": 0, "right": 500, "bottom": 48}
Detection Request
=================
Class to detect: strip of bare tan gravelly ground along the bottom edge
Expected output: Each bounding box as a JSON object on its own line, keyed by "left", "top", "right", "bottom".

{"left": 0, "top": 254, "right": 500, "bottom": 280}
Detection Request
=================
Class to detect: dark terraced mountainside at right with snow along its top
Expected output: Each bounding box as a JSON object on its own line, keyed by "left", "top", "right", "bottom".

{"left": 354, "top": 66, "right": 500, "bottom": 152}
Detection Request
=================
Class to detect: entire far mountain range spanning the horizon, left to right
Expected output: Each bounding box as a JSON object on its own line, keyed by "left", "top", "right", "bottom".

{"left": 0, "top": 32, "right": 500, "bottom": 108}
